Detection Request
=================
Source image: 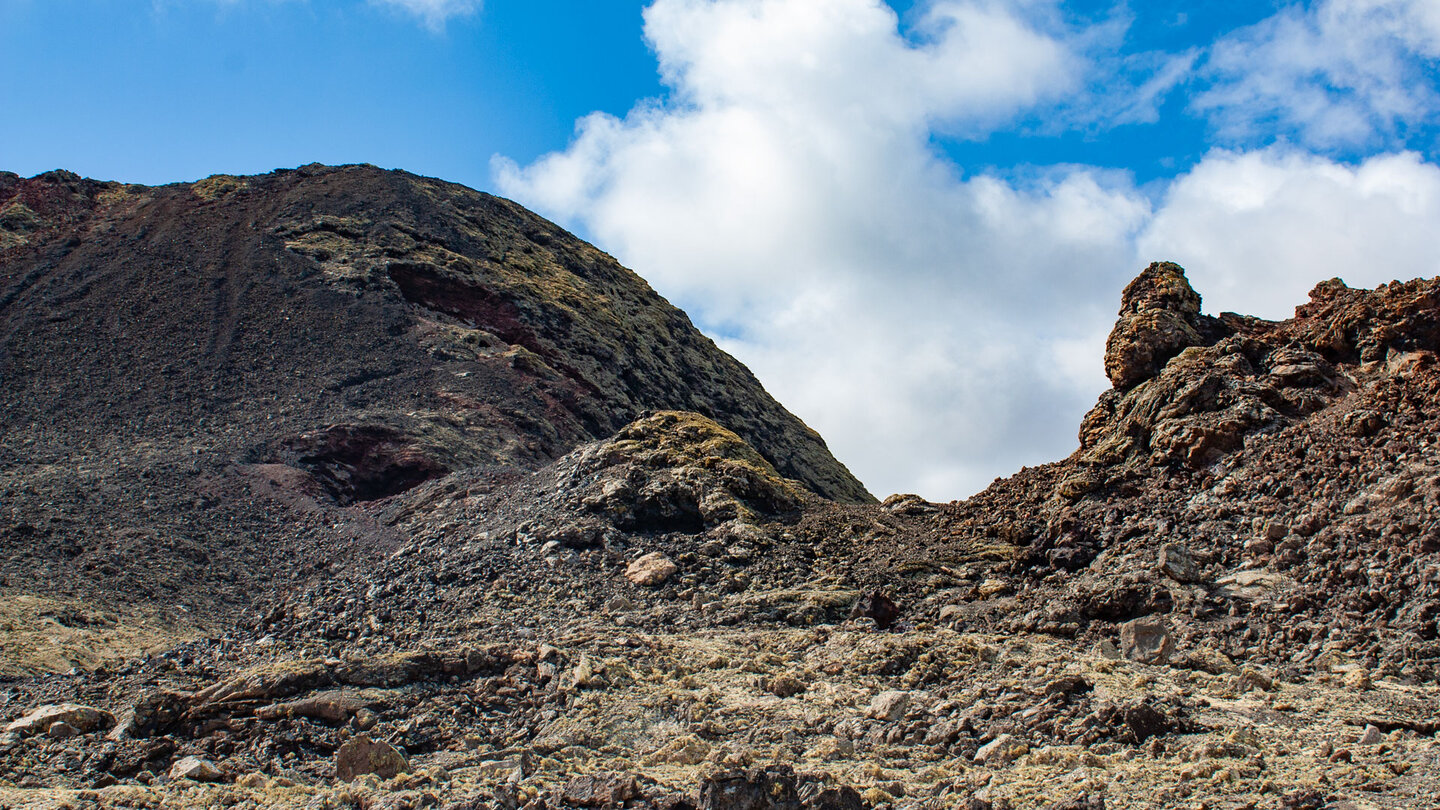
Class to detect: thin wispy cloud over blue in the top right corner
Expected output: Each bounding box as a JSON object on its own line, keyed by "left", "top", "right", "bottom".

{"left": 1192, "top": 0, "right": 1440, "bottom": 148}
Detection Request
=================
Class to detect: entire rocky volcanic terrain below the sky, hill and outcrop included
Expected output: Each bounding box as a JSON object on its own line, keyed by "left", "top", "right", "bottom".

{"left": 0, "top": 169, "right": 1440, "bottom": 810}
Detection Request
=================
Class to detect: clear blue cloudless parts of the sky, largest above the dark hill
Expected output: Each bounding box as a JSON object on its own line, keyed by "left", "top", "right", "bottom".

{"left": 0, "top": 0, "right": 1436, "bottom": 187}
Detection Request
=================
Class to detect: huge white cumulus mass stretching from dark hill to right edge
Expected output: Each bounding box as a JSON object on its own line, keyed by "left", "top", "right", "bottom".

{"left": 494, "top": 0, "right": 1440, "bottom": 499}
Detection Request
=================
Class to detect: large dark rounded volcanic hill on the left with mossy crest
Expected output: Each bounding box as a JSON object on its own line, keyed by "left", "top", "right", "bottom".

{"left": 0, "top": 166, "right": 870, "bottom": 672}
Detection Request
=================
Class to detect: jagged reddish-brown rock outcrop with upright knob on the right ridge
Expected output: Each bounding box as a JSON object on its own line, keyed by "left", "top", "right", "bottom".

{"left": 1080, "top": 264, "right": 1370, "bottom": 470}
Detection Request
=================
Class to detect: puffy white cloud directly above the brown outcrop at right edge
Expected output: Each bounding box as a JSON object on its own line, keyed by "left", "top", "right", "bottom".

{"left": 1138, "top": 148, "right": 1440, "bottom": 319}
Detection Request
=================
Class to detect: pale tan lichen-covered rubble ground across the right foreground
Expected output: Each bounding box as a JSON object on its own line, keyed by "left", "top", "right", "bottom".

{"left": 0, "top": 626, "right": 1440, "bottom": 810}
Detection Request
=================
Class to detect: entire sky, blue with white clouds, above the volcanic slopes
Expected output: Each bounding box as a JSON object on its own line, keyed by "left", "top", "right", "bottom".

{"left": 0, "top": 0, "right": 1440, "bottom": 499}
